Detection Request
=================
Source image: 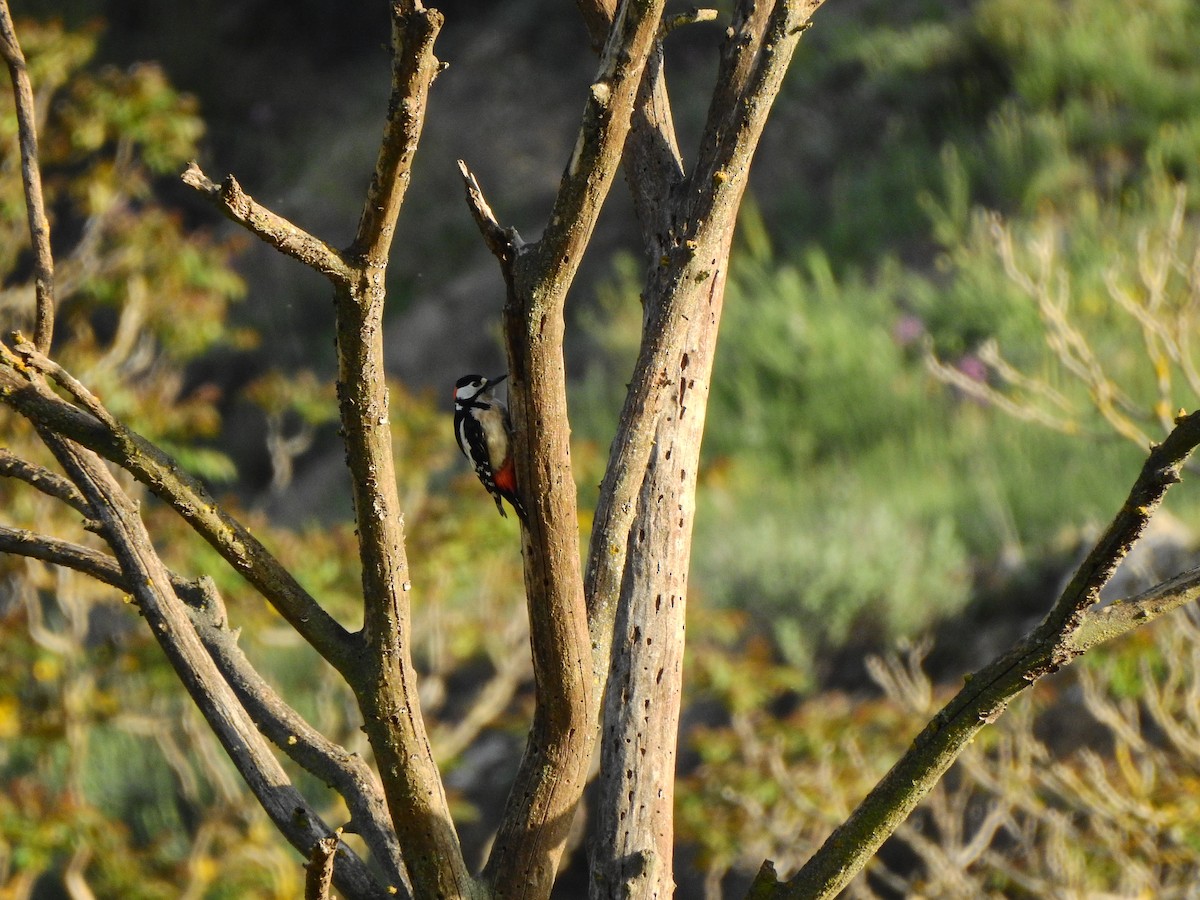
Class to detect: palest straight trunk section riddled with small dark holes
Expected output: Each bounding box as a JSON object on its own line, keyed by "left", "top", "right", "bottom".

{"left": 592, "top": 230, "right": 733, "bottom": 900}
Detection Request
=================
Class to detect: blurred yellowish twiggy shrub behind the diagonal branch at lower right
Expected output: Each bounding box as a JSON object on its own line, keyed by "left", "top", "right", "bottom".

{"left": 678, "top": 613, "right": 1200, "bottom": 898}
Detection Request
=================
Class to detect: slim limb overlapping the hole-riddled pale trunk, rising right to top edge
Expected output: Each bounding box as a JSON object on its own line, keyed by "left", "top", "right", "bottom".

{"left": 586, "top": 0, "right": 821, "bottom": 689}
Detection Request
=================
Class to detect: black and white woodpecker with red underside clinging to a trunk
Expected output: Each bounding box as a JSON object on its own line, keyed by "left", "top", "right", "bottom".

{"left": 454, "top": 374, "right": 524, "bottom": 522}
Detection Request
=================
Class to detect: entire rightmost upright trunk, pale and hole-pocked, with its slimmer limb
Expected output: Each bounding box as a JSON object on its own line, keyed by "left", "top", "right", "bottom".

{"left": 586, "top": 1, "right": 818, "bottom": 898}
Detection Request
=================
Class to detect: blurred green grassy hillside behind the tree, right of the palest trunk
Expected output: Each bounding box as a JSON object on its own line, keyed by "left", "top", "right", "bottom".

{"left": 576, "top": 0, "right": 1200, "bottom": 681}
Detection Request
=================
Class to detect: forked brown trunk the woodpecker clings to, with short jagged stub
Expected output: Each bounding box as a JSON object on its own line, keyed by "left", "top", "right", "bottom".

{"left": 464, "top": 0, "right": 664, "bottom": 896}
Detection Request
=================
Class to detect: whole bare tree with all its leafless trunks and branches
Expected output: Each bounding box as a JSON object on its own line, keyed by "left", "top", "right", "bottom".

{"left": 0, "top": 0, "right": 1200, "bottom": 898}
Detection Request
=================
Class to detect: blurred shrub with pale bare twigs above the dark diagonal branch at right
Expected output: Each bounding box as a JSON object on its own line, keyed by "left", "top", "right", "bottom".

{"left": 929, "top": 168, "right": 1200, "bottom": 448}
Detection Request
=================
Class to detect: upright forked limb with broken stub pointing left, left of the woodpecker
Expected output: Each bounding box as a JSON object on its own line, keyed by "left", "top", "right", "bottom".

{"left": 185, "top": 0, "right": 475, "bottom": 896}
